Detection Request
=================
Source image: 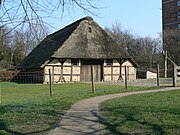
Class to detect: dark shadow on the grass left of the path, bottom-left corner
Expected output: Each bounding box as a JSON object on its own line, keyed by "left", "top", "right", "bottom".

{"left": 0, "top": 105, "right": 62, "bottom": 135}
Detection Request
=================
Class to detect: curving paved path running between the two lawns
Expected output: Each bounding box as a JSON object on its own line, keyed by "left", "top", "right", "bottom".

{"left": 49, "top": 87, "right": 180, "bottom": 135}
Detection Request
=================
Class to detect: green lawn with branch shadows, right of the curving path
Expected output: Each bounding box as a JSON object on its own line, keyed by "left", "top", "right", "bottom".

{"left": 101, "top": 90, "right": 180, "bottom": 135}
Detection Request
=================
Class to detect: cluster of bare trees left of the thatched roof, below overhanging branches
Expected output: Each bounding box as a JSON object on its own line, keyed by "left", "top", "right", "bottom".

{"left": 0, "top": 27, "right": 48, "bottom": 69}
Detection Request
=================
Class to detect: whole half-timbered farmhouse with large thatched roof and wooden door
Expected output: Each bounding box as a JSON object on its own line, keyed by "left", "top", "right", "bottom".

{"left": 18, "top": 17, "right": 137, "bottom": 83}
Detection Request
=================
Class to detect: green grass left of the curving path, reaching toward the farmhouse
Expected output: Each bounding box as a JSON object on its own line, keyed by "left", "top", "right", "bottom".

{"left": 0, "top": 82, "right": 160, "bottom": 135}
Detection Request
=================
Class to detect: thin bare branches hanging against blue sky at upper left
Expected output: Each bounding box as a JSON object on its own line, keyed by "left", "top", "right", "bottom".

{"left": 0, "top": 0, "right": 98, "bottom": 34}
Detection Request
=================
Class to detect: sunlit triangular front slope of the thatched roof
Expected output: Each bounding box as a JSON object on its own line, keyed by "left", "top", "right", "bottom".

{"left": 52, "top": 20, "right": 129, "bottom": 59}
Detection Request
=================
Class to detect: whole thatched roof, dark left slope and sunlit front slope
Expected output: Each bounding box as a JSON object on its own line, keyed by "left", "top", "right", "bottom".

{"left": 19, "top": 17, "right": 137, "bottom": 68}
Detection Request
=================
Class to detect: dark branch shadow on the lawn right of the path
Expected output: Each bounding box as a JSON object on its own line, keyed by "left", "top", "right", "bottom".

{"left": 99, "top": 107, "right": 169, "bottom": 135}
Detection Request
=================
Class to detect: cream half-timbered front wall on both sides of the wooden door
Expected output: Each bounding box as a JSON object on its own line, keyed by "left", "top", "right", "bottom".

{"left": 44, "top": 59, "right": 136, "bottom": 83}
